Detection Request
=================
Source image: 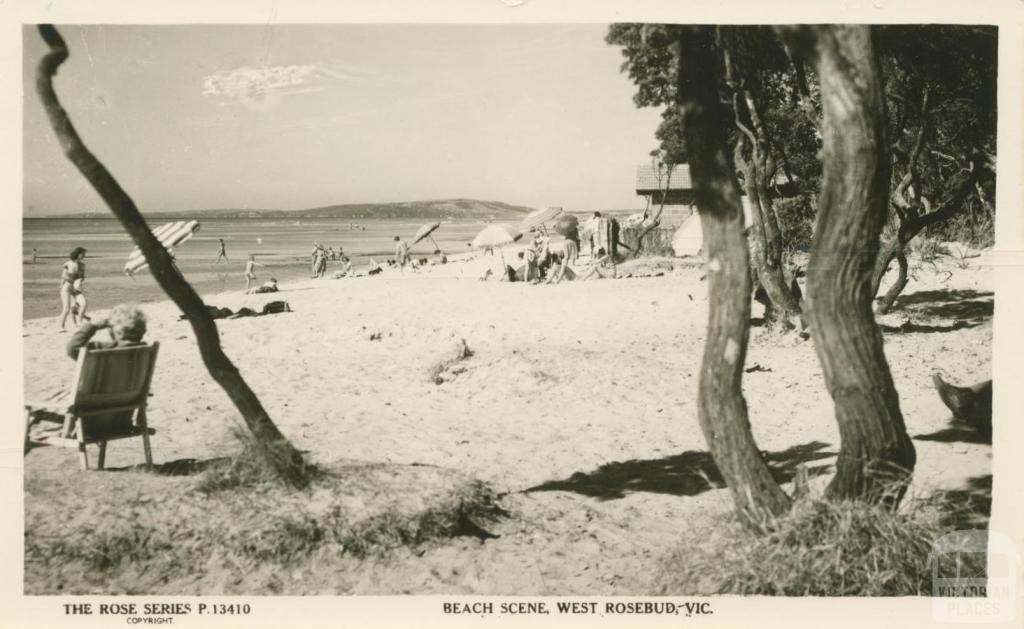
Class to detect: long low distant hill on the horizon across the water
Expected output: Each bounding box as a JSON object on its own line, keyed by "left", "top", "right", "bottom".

{"left": 43, "top": 199, "right": 532, "bottom": 220}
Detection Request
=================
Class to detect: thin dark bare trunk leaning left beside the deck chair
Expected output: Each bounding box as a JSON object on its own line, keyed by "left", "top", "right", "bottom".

{"left": 36, "top": 25, "right": 308, "bottom": 488}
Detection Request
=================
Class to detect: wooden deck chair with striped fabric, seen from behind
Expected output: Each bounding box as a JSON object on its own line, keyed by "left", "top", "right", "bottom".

{"left": 25, "top": 343, "right": 160, "bottom": 469}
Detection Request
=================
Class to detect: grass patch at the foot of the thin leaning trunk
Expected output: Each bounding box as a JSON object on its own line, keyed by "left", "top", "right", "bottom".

{"left": 25, "top": 450, "right": 504, "bottom": 594}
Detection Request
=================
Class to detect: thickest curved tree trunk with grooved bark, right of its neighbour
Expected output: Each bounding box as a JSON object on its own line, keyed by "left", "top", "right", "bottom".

{"left": 806, "top": 26, "right": 915, "bottom": 505}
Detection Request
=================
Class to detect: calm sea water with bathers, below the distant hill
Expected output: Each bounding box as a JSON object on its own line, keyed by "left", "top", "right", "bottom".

{"left": 22, "top": 218, "right": 486, "bottom": 319}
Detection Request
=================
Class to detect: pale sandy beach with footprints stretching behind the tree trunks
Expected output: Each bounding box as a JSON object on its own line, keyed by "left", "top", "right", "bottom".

{"left": 24, "top": 254, "right": 993, "bottom": 594}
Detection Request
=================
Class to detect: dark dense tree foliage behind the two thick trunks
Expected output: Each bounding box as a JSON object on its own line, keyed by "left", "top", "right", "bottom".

{"left": 606, "top": 24, "right": 997, "bottom": 310}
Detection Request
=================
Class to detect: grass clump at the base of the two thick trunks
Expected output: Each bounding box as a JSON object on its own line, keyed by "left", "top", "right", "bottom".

{"left": 658, "top": 496, "right": 985, "bottom": 596}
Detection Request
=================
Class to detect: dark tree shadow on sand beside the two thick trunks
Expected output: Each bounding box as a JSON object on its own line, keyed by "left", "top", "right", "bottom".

{"left": 524, "top": 442, "right": 837, "bottom": 500}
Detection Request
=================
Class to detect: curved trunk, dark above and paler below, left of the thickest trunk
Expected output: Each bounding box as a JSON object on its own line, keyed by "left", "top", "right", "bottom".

{"left": 677, "top": 27, "right": 790, "bottom": 528}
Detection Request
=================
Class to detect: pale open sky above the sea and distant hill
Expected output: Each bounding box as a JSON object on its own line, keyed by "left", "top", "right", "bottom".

{"left": 23, "top": 25, "right": 660, "bottom": 217}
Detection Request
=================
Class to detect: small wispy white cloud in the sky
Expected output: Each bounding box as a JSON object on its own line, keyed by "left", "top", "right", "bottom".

{"left": 203, "top": 65, "right": 354, "bottom": 110}
